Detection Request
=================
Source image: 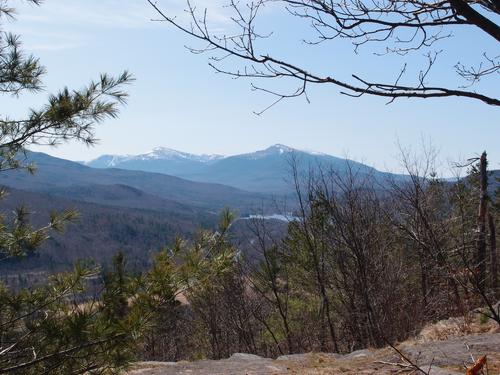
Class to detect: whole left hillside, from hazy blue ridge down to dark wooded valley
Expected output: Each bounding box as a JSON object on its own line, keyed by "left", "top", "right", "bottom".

{"left": 0, "top": 152, "right": 271, "bottom": 275}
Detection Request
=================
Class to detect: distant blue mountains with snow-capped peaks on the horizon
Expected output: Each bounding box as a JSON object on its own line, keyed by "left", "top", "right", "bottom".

{"left": 85, "top": 144, "right": 396, "bottom": 194}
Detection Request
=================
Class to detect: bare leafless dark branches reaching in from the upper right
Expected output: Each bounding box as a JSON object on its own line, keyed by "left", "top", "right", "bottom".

{"left": 148, "top": 0, "right": 500, "bottom": 111}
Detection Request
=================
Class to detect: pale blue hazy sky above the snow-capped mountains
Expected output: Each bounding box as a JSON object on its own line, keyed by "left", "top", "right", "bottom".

{"left": 2, "top": 0, "right": 500, "bottom": 175}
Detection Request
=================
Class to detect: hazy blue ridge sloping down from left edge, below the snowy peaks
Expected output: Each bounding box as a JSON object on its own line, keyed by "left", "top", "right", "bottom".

{"left": 0, "top": 152, "right": 268, "bottom": 212}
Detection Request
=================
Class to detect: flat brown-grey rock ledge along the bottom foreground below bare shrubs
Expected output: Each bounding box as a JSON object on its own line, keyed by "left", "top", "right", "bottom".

{"left": 129, "top": 333, "right": 500, "bottom": 375}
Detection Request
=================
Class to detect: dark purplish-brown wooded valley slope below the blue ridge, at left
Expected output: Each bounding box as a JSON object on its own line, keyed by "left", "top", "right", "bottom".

{"left": 1, "top": 189, "right": 217, "bottom": 276}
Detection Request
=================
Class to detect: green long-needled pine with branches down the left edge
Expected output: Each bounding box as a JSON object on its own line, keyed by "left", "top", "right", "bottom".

{"left": 0, "top": 0, "right": 145, "bottom": 374}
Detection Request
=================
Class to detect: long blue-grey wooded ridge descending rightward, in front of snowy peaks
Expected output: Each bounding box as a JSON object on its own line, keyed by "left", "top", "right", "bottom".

{"left": 0, "top": 152, "right": 269, "bottom": 212}
